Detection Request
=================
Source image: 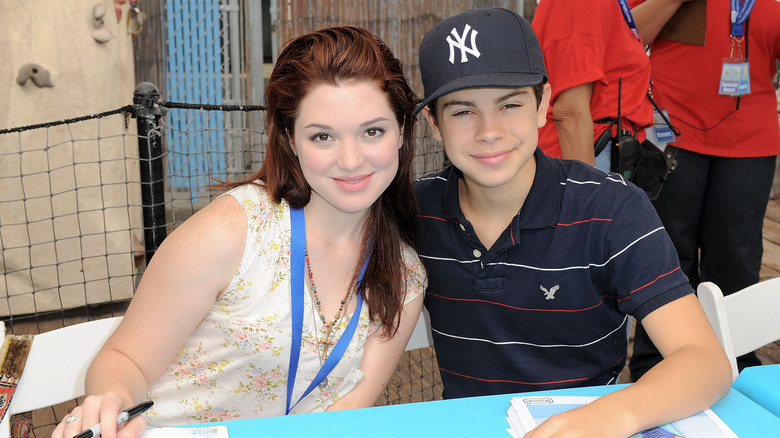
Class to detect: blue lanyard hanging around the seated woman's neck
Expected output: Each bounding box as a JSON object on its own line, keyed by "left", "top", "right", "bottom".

{"left": 285, "top": 207, "right": 368, "bottom": 415}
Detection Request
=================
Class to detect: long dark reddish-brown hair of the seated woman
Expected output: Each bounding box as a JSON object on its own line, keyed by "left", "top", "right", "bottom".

{"left": 221, "top": 26, "right": 417, "bottom": 337}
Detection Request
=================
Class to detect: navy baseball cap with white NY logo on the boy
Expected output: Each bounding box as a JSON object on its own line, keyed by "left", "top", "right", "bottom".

{"left": 414, "top": 8, "right": 547, "bottom": 114}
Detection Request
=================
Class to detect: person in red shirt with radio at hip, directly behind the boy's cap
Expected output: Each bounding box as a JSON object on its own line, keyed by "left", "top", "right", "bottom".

{"left": 532, "top": 0, "right": 653, "bottom": 171}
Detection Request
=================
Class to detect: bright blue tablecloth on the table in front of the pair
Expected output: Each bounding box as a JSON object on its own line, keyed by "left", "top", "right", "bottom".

{"left": 175, "top": 385, "right": 780, "bottom": 438}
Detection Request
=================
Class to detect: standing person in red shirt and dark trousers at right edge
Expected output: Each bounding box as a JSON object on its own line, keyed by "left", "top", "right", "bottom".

{"left": 629, "top": 0, "right": 780, "bottom": 379}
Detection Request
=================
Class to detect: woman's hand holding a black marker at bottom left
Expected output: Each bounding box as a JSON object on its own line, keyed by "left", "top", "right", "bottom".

{"left": 51, "top": 392, "right": 146, "bottom": 438}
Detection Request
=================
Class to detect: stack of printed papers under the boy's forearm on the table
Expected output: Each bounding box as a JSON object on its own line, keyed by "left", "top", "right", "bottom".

{"left": 507, "top": 396, "right": 738, "bottom": 438}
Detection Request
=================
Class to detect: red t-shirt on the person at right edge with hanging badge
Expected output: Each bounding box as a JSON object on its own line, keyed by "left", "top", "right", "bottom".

{"left": 631, "top": 0, "right": 780, "bottom": 158}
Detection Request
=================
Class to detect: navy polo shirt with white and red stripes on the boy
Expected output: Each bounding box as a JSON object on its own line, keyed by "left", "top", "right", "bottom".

{"left": 415, "top": 148, "right": 693, "bottom": 398}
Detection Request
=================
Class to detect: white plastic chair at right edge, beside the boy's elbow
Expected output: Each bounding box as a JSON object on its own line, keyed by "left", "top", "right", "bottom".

{"left": 696, "top": 278, "right": 780, "bottom": 381}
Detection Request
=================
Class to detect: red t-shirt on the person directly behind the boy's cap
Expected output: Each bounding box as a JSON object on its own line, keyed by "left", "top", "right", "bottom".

{"left": 532, "top": 0, "right": 653, "bottom": 157}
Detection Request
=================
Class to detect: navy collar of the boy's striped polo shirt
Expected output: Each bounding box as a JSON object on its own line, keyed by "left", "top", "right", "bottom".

{"left": 443, "top": 147, "right": 565, "bottom": 232}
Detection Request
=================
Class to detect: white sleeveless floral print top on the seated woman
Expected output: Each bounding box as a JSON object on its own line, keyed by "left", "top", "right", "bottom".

{"left": 146, "top": 185, "right": 426, "bottom": 426}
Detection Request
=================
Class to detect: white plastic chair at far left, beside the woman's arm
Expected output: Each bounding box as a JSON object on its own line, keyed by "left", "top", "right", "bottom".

{"left": 0, "top": 316, "right": 122, "bottom": 438}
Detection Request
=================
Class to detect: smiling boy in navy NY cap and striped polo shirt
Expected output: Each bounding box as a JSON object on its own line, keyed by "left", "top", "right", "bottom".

{"left": 416, "top": 9, "right": 730, "bottom": 437}
